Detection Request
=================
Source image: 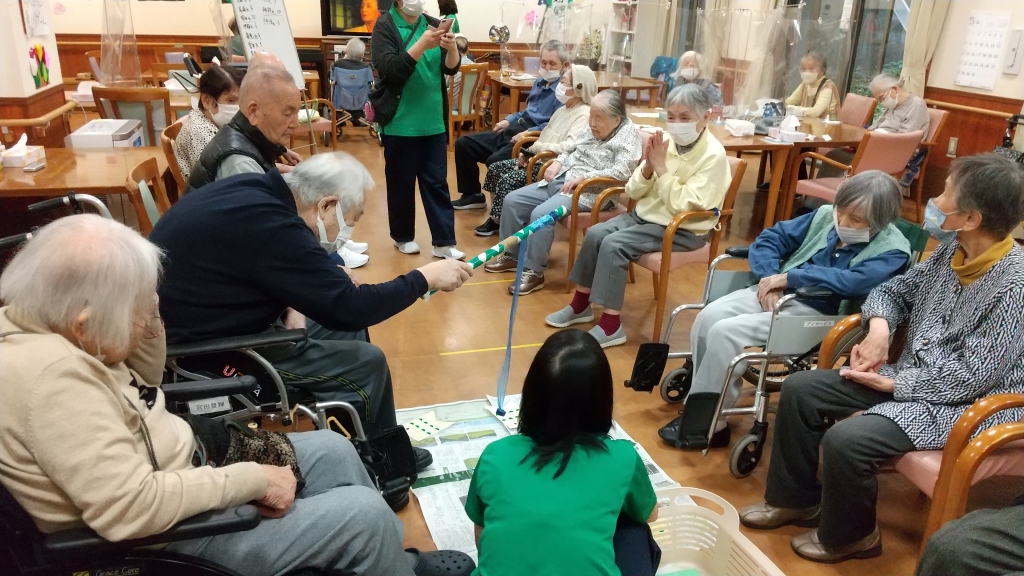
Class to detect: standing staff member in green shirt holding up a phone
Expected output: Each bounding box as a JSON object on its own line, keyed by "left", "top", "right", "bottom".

{"left": 372, "top": 0, "right": 466, "bottom": 259}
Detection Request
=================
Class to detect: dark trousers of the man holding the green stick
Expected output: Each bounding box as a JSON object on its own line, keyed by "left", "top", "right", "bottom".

{"left": 258, "top": 319, "right": 397, "bottom": 427}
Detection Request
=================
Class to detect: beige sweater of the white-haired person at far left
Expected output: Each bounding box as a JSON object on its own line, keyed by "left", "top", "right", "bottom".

{"left": 0, "top": 307, "right": 267, "bottom": 541}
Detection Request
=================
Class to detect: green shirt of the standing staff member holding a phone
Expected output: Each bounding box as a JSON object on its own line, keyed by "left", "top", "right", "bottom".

{"left": 382, "top": 5, "right": 444, "bottom": 136}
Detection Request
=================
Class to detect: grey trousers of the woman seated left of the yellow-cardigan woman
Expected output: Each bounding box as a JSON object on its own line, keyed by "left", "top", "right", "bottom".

{"left": 498, "top": 178, "right": 572, "bottom": 273}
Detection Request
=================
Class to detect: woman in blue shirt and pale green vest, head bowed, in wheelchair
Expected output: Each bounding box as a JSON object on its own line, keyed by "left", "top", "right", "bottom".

{"left": 658, "top": 170, "right": 910, "bottom": 450}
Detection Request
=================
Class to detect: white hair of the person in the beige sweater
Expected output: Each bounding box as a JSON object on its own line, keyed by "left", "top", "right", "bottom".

{"left": 0, "top": 214, "right": 162, "bottom": 351}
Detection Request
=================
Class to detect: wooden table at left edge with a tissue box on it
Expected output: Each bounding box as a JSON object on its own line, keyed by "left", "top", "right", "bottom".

{"left": 0, "top": 148, "right": 167, "bottom": 198}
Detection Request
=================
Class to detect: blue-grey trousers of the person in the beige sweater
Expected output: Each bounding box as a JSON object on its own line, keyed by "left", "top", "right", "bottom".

{"left": 167, "top": 430, "right": 413, "bottom": 576}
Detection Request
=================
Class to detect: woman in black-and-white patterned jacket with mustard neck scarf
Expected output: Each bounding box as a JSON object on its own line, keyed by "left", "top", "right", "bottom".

{"left": 740, "top": 154, "right": 1024, "bottom": 563}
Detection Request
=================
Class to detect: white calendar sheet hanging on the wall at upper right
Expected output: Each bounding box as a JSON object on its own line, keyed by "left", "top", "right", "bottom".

{"left": 953, "top": 11, "right": 1011, "bottom": 90}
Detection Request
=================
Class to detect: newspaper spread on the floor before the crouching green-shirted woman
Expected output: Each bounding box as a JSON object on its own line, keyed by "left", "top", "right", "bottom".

{"left": 397, "top": 395, "right": 679, "bottom": 561}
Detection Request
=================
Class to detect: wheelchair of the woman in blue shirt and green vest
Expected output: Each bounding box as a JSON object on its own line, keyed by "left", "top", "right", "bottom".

{"left": 626, "top": 219, "right": 928, "bottom": 478}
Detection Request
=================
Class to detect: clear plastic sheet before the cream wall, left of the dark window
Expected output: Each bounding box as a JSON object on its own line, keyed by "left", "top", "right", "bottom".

{"left": 692, "top": 9, "right": 786, "bottom": 118}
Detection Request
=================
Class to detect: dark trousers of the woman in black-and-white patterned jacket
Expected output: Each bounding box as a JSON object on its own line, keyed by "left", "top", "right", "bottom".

{"left": 765, "top": 370, "right": 914, "bottom": 546}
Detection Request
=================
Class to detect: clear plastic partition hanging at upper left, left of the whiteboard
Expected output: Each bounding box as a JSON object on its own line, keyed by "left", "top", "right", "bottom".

{"left": 99, "top": 0, "right": 142, "bottom": 87}
